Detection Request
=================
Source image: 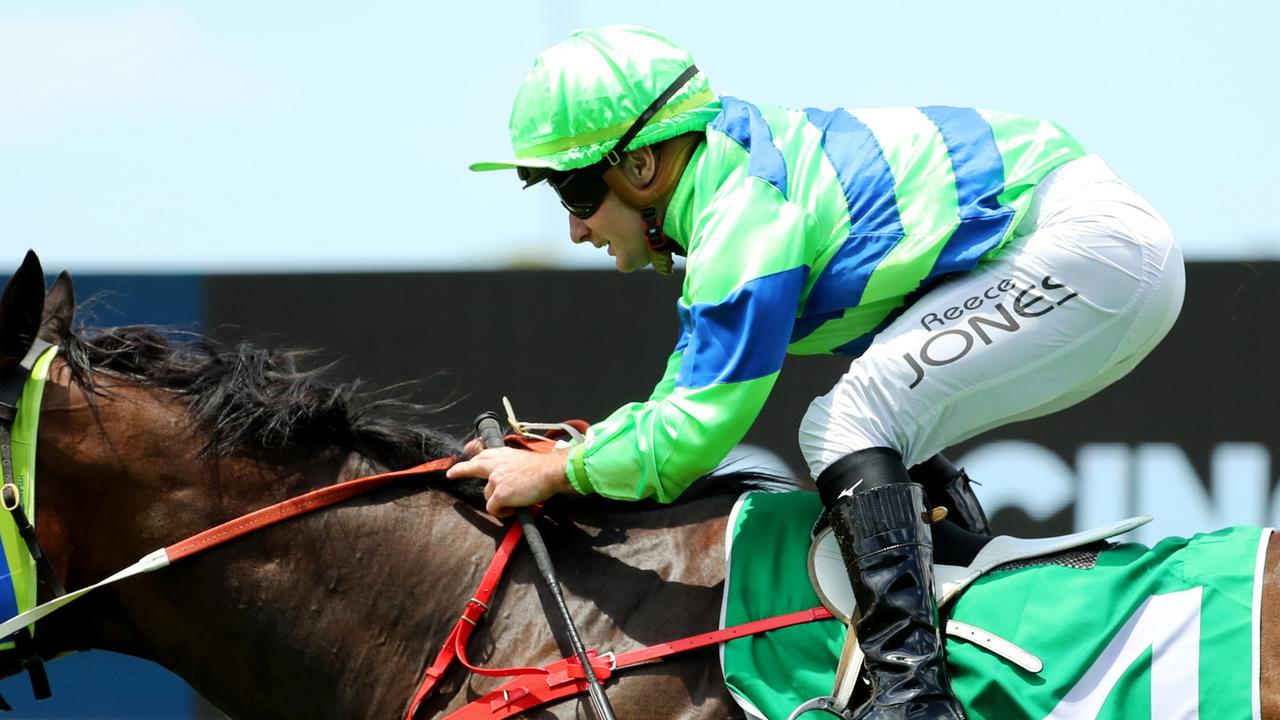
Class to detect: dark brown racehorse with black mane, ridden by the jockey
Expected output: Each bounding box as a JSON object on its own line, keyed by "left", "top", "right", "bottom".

{"left": 0, "top": 249, "right": 1280, "bottom": 719}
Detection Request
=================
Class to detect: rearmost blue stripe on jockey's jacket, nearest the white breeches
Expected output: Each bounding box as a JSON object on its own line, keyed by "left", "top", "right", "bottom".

{"left": 919, "top": 106, "right": 1014, "bottom": 278}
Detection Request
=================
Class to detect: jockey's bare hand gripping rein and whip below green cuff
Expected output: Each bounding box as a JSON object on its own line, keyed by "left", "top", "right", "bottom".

{"left": 447, "top": 447, "right": 577, "bottom": 518}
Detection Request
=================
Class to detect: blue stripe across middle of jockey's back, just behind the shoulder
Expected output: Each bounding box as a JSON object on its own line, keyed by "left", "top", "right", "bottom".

{"left": 803, "top": 108, "right": 904, "bottom": 316}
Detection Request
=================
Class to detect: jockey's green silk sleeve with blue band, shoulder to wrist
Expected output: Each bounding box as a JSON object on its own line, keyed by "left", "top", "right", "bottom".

{"left": 567, "top": 172, "right": 812, "bottom": 502}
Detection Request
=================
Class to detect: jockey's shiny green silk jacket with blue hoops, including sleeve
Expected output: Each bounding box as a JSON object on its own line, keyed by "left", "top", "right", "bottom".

{"left": 571, "top": 103, "right": 1085, "bottom": 501}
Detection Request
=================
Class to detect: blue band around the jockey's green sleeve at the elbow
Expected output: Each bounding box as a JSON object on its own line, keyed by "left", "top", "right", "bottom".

{"left": 676, "top": 265, "right": 809, "bottom": 388}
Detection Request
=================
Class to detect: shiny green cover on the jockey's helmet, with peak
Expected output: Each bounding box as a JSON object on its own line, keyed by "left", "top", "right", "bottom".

{"left": 471, "top": 26, "right": 719, "bottom": 170}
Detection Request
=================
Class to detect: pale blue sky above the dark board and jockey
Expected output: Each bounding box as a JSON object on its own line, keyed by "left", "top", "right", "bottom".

{"left": 0, "top": 0, "right": 1280, "bottom": 273}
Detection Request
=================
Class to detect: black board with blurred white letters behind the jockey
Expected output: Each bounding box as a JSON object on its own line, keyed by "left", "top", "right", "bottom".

{"left": 205, "top": 263, "right": 1280, "bottom": 534}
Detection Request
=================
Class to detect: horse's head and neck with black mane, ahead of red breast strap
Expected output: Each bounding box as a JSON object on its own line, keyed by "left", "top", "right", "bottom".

{"left": 0, "top": 252, "right": 499, "bottom": 717}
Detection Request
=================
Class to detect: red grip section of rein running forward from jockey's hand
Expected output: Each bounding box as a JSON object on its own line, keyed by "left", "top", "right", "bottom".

{"left": 164, "top": 457, "right": 457, "bottom": 562}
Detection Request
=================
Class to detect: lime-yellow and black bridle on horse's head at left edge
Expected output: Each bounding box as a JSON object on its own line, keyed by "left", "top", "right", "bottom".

{"left": 0, "top": 340, "right": 67, "bottom": 711}
